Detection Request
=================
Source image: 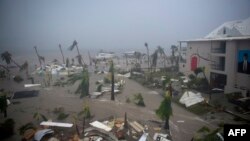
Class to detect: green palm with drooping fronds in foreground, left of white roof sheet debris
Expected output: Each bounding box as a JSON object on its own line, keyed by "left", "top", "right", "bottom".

{"left": 156, "top": 90, "right": 173, "bottom": 130}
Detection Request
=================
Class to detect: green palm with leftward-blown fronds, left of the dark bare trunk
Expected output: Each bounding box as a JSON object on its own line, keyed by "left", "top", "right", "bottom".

{"left": 68, "top": 69, "right": 89, "bottom": 98}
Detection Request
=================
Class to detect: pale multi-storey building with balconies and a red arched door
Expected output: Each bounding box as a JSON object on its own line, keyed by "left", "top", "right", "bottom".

{"left": 179, "top": 18, "right": 250, "bottom": 94}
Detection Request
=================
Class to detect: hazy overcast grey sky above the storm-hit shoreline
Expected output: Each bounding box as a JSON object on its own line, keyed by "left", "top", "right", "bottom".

{"left": 0, "top": 0, "right": 250, "bottom": 52}
